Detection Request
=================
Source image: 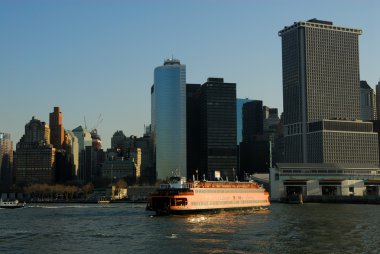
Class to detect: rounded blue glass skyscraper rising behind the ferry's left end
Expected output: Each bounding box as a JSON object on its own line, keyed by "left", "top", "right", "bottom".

{"left": 151, "top": 59, "right": 187, "bottom": 179}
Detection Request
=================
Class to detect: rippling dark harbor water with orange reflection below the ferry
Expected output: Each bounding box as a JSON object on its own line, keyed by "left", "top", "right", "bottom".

{"left": 0, "top": 204, "right": 380, "bottom": 254}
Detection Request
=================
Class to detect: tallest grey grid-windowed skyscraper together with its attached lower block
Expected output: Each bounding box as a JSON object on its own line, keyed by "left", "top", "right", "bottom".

{"left": 279, "top": 19, "right": 378, "bottom": 163}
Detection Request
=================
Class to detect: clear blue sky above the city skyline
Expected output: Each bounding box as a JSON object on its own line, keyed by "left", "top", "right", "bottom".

{"left": 0, "top": 0, "right": 380, "bottom": 149}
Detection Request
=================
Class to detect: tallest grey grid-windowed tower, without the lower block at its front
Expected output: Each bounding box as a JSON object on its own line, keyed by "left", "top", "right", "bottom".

{"left": 279, "top": 19, "right": 368, "bottom": 163}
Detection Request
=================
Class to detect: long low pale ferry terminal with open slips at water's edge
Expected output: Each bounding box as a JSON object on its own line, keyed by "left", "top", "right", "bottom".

{"left": 270, "top": 163, "right": 380, "bottom": 201}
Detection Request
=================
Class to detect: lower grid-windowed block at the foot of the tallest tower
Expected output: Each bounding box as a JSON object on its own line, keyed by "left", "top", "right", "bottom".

{"left": 308, "top": 119, "right": 379, "bottom": 165}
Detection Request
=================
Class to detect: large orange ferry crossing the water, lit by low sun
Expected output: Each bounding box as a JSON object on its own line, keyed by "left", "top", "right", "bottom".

{"left": 146, "top": 177, "right": 270, "bottom": 215}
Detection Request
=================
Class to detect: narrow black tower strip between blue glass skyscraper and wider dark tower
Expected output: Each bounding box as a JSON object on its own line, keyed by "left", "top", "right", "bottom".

{"left": 186, "top": 84, "right": 201, "bottom": 179}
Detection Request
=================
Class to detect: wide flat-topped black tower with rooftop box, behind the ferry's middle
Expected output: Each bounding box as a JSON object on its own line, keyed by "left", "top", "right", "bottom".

{"left": 199, "top": 78, "right": 237, "bottom": 180}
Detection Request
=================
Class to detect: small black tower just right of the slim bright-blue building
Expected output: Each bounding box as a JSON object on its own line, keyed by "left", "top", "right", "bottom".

{"left": 243, "top": 100, "right": 263, "bottom": 142}
